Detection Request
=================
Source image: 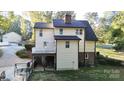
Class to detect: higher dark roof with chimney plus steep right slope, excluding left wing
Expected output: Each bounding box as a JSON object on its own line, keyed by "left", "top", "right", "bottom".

{"left": 53, "top": 19, "right": 98, "bottom": 41}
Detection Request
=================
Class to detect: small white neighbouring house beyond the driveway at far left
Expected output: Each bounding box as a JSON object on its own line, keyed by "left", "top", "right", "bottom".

{"left": 3, "top": 32, "right": 22, "bottom": 43}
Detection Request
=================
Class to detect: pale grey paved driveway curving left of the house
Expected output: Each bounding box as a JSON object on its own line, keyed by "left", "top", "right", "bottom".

{"left": 0, "top": 44, "right": 30, "bottom": 67}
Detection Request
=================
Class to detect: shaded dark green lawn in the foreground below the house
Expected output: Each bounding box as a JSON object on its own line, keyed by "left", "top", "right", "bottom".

{"left": 29, "top": 65, "right": 124, "bottom": 81}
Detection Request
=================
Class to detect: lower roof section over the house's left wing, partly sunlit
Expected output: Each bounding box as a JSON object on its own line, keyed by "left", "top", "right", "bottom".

{"left": 34, "top": 22, "right": 53, "bottom": 29}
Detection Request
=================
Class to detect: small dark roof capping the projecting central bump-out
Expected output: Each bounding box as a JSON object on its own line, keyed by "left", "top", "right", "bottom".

{"left": 54, "top": 35, "right": 81, "bottom": 40}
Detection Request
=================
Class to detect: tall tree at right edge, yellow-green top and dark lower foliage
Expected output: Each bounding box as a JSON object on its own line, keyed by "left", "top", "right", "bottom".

{"left": 110, "top": 11, "right": 124, "bottom": 50}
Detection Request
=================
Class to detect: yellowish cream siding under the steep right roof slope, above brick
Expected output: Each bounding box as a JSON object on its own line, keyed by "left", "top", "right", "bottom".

{"left": 85, "top": 41, "right": 95, "bottom": 52}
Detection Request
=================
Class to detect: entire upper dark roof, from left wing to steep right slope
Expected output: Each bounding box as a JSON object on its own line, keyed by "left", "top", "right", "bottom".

{"left": 34, "top": 19, "right": 98, "bottom": 41}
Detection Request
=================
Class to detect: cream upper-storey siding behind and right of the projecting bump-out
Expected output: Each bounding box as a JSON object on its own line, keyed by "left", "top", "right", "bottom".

{"left": 54, "top": 28, "right": 84, "bottom": 52}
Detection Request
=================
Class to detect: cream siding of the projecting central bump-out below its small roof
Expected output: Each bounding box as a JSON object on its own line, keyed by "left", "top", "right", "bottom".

{"left": 57, "top": 40, "right": 78, "bottom": 70}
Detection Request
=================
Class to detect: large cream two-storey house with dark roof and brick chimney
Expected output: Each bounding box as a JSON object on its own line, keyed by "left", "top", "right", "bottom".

{"left": 32, "top": 14, "right": 97, "bottom": 70}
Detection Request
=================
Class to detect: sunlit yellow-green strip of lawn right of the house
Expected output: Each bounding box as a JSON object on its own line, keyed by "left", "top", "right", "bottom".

{"left": 96, "top": 48, "right": 124, "bottom": 61}
